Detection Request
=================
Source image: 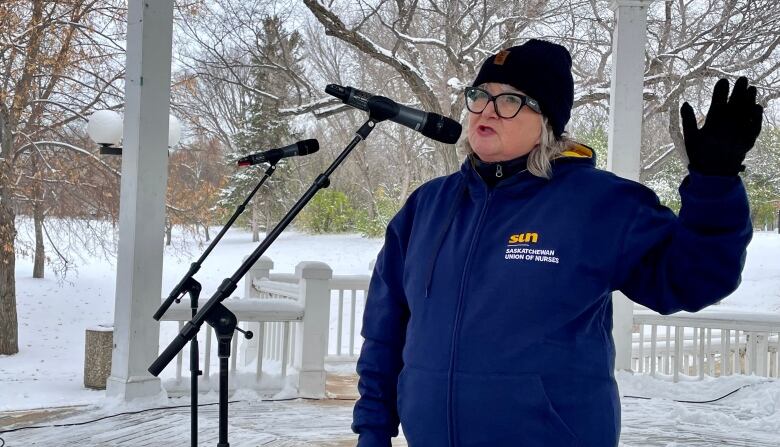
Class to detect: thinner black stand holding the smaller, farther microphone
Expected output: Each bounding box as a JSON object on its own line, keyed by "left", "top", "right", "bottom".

{"left": 154, "top": 159, "right": 279, "bottom": 447}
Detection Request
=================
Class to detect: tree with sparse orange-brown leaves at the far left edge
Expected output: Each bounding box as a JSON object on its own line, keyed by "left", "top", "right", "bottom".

{"left": 0, "top": 0, "right": 124, "bottom": 354}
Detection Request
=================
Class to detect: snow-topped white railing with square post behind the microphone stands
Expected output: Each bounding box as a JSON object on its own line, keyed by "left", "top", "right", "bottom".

{"left": 163, "top": 258, "right": 332, "bottom": 397}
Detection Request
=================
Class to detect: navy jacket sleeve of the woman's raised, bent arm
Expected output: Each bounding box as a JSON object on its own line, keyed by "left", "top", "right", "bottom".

{"left": 613, "top": 171, "right": 753, "bottom": 315}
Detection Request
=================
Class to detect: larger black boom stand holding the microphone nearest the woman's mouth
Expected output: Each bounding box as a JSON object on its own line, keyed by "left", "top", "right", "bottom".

{"left": 149, "top": 110, "right": 386, "bottom": 447}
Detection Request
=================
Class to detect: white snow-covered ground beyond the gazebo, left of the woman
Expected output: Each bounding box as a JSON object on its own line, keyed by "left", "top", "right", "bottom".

{"left": 0, "top": 231, "right": 382, "bottom": 411}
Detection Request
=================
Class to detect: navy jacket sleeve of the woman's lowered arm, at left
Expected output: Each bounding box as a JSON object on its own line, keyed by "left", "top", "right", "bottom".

{"left": 352, "top": 202, "right": 410, "bottom": 447}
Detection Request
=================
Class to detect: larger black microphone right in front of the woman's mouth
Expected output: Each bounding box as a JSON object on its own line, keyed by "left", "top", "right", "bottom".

{"left": 325, "top": 84, "right": 463, "bottom": 144}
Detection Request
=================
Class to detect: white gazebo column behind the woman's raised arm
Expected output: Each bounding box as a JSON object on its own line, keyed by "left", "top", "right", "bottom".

{"left": 607, "top": 0, "right": 653, "bottom": 369}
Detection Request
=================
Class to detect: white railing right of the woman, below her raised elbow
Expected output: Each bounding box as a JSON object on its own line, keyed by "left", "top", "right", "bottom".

{"left": 631, "top": 310, "right": 780, "bottom": 382}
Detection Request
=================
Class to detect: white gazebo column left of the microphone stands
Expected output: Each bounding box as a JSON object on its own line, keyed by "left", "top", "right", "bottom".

{"left": 107, "top": 0, "right": 173, "bottom": 400}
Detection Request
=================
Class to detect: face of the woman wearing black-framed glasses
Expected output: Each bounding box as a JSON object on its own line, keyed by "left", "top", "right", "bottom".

{"left": 468, "top": 82, "right": 542, "bottom": 162}
